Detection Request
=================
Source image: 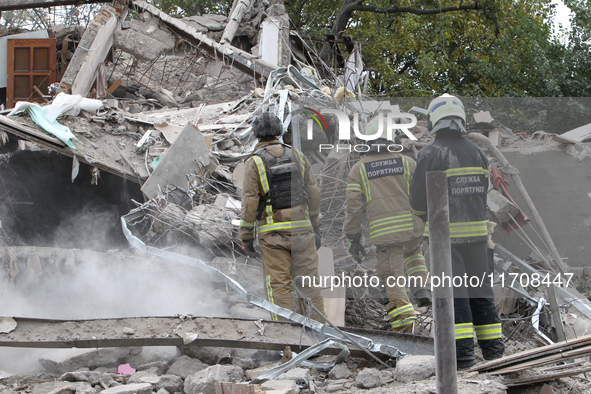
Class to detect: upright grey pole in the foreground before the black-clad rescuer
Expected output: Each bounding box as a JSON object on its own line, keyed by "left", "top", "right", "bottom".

{"left": 427, "top": 171, "right": 458, "bottom": 394}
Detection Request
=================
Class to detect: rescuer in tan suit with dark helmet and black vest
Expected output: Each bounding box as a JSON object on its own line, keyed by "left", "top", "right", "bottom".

{"left": 239, "top": 112, "right": 326, "bottom": 323}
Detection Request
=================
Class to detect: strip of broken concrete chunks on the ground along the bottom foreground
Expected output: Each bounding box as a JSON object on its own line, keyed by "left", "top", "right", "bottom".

{"left": 0, "top": 348, "right": 506, "bottom": 394}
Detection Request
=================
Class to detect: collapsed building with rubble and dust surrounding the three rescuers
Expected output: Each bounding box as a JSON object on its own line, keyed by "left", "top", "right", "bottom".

{"left": 0, "top": 1, "right": 591, "bottom": 394}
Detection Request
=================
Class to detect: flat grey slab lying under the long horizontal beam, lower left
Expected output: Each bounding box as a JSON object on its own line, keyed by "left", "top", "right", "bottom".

{"left": 39, "top": 347, "right": 142, "bottom": 375}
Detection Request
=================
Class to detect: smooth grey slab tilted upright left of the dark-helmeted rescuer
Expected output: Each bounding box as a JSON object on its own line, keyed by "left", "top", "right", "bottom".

{"left": 141, "top": 124, "right": 209, "bottom": 198}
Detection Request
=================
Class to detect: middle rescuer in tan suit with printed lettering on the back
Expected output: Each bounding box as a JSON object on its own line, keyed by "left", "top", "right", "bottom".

{"left": 345, "top": 116, "right": 431, "bottom": 333}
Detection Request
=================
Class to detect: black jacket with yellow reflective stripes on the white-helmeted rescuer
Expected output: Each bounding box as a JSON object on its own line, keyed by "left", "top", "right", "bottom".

{"left": 410, "top": 131, "right": 488, "bottom": 243}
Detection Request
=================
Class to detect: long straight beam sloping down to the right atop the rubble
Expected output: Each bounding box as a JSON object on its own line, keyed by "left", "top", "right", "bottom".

{"left": 133, "top": 0, "right": 278, "bottom": 79}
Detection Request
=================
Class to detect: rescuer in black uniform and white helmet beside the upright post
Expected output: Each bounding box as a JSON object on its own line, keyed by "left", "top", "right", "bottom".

{"left": 410, "top": 94, "right": 505, "bottom": 369}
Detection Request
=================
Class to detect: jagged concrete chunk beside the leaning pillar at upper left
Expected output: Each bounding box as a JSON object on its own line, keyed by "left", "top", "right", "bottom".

{"left": 113, "top": 14, "right": 176, "bottom": 62}
